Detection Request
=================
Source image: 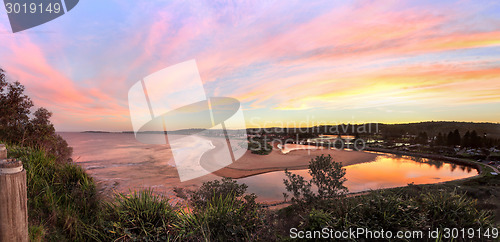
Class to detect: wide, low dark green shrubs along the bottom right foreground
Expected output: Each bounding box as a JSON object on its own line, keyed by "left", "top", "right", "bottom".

{"left": 281, "top": 189, "right": 494, "bottom": 237}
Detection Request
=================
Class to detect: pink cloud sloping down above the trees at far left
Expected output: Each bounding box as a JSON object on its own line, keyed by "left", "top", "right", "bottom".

{"left": 0, "top": 23, "right": 132, "bottom": 130}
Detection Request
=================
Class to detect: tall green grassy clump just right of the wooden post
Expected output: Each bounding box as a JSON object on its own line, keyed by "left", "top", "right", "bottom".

{"left": 8, "top": 146, "right": 99, "bottom": 240}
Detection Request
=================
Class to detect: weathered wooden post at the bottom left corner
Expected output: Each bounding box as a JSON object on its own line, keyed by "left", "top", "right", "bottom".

{"left": 0, "top": 144, "right": 28, "bottom": 242}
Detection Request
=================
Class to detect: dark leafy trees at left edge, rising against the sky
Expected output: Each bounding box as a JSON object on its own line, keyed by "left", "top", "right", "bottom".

{"left": 0, "top": 68, "right": 72, "bottom": 162}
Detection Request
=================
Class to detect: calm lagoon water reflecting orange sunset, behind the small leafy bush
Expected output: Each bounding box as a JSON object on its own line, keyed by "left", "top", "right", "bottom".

{"left": 238, "top": 154, "right": 478, "bottom": 201}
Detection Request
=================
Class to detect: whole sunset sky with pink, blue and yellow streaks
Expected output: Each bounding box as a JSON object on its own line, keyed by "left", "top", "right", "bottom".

{"left": 0, "top": 0, "right": 500, "bottom": 131}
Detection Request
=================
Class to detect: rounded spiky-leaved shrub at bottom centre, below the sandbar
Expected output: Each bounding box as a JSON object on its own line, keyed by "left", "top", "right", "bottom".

{"left": 179, "top": 178, "right": 265, "bottom": 241}
